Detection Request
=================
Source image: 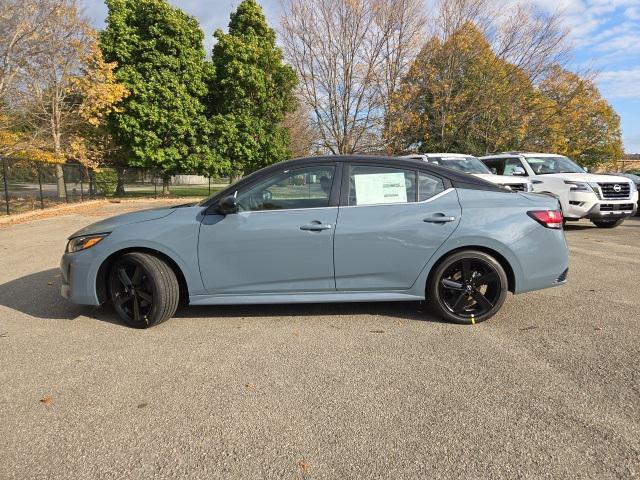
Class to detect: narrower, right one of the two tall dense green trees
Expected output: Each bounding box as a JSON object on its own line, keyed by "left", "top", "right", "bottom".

{"left": 207, "top": 0, "right": 297, "bottom": 178}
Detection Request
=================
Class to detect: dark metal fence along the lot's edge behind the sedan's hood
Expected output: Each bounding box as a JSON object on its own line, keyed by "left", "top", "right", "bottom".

{"left": 0, "top": 158, "right": 229, "bottom": 215}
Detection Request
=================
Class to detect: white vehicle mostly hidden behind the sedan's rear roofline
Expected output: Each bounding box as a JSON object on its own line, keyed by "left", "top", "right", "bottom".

{"left": 405, "top": 153, "right": 533, "bottom": 192}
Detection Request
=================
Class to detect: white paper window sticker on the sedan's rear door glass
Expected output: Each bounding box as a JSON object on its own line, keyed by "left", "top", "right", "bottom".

{"left": 354, "top": 172, "right": 407, "bottom": 205}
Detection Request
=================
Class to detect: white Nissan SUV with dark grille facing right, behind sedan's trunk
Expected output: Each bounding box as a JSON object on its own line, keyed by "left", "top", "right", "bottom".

{"left": 480, "top": 152, "right": 638, "bottom": 228}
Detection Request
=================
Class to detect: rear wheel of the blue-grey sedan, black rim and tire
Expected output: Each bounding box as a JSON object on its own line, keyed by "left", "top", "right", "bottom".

{"left": 426, "top": 250, "right": 509, "bottom": 325}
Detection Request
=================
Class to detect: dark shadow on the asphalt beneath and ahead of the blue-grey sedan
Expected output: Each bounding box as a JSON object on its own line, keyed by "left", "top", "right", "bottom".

{"left": 0, "top": 268, "right": 443, "bottom": 325}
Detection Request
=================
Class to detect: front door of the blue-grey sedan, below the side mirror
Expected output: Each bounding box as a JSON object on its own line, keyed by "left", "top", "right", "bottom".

{"left": 198, "top": 164, "right": 339, "bottom": 295}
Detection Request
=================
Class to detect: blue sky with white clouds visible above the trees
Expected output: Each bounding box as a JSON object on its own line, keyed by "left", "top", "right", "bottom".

{"left": 79, "top": 0, "right": 640, "bottom": 153}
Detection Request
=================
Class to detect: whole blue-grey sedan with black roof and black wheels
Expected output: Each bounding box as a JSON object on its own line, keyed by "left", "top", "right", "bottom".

{"left": 61, "top": 156, "right": 568, "bottom": 328}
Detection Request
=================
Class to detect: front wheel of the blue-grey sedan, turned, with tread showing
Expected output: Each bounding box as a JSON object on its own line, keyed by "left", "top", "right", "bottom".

{"left": 109, "top": 252, "right": 180, "bottom": 328}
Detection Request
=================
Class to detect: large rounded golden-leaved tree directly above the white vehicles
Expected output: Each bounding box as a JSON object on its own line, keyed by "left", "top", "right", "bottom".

{"left": 385, "top": 22, "right": 534, "bottom": 154}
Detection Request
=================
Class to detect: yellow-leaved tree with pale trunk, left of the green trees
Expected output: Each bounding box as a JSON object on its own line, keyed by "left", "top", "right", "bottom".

{"left": 20, "top": 0, "right": 126, "bottom": 197}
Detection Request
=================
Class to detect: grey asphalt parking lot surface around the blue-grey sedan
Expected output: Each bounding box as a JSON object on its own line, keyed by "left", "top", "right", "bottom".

{"left": 0, "top": 204, "right": 640, "bottom": 479}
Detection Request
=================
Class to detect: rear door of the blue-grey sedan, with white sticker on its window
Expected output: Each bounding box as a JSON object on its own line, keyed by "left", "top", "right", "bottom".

{"left": 334, "top": 164, "right": 461, "bottom": 291}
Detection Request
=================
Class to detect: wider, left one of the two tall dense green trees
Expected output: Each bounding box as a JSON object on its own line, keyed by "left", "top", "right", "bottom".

{"left": 100, "top": 0, "right": 210, "bottom": 193}
